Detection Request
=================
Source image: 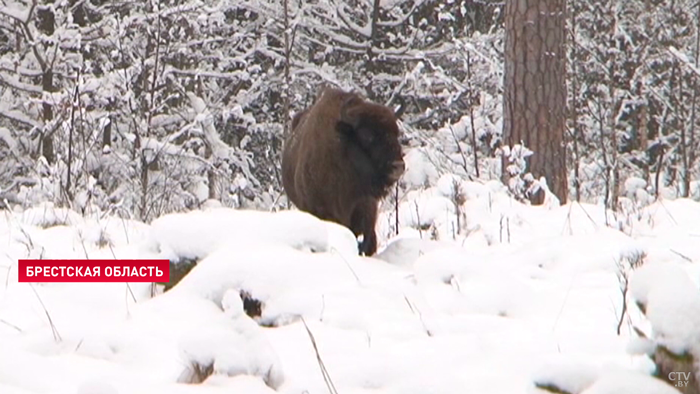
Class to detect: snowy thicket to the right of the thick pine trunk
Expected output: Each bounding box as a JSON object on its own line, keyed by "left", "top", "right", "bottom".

{"left": 569, "top": 0, "right": 698, "bottom": 205}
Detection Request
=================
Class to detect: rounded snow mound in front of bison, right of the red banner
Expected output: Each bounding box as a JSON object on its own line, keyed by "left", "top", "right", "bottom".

{"left": 173, "top": 241, "right": 418, "bottom": 329}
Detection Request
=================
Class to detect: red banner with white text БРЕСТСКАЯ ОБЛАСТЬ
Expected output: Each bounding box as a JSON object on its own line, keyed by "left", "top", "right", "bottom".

{"left": 18, "top": 260, "right": 170, "bottom": 282}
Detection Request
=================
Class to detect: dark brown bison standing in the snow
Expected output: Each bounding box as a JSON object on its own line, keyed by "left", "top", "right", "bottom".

{"left": 282, "top": 88, "right": 404, "bottom": 256}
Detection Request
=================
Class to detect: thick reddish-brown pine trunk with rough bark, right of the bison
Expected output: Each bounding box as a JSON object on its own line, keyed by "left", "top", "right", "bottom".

{"left": 503, "top": 0, "right": 568, "bottom": 203}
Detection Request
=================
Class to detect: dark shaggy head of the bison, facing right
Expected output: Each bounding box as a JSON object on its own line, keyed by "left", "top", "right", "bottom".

{"left": 337, "top": 95, "right": 405, "bottom": 195}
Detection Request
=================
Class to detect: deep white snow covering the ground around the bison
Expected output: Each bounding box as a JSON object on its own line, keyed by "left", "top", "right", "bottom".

{"left": 0, "top": 181, "right": 700, "bottom": 394}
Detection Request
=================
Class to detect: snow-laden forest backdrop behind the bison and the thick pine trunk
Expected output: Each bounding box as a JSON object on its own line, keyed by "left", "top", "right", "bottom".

{"left": 0, "top": 0, "right": 700, "bottom": 220}
